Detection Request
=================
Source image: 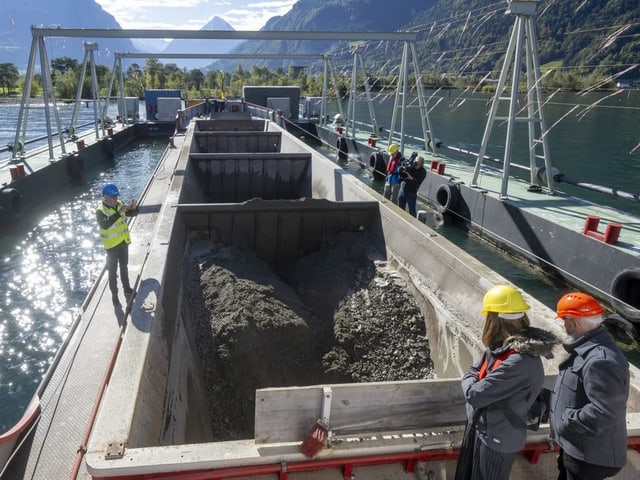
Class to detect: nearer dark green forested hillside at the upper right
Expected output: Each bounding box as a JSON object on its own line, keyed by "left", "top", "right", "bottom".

{"left": 410, "top": 0, "right": 640, "bottom": 76}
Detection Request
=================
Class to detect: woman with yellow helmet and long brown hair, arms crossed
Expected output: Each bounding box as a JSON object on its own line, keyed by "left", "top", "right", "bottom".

{"left": 455, "top": 285, "right": 560, "bottom": 480}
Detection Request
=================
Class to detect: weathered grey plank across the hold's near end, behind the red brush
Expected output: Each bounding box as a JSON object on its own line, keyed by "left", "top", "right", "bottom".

{"left": 255, "top": 379, "right": 466, "bottom": 443}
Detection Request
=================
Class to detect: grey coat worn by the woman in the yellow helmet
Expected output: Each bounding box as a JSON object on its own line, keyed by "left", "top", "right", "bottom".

{"left": 462, "top": 327, "right": 559, "bottom": 453}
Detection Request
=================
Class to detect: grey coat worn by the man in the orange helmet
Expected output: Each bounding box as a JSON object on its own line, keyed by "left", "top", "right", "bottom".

{"left": 550, "top": 326, "right": 629, "bottom": 467}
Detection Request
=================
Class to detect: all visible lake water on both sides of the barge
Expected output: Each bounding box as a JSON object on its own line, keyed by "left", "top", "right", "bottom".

{"left": 0, "top": 91, "right": 640, "bottom": 432}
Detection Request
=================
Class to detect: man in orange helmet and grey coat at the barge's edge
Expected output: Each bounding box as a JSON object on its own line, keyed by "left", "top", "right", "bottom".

{"left": 550, "top": 292, "right": 629, "bottom": 480}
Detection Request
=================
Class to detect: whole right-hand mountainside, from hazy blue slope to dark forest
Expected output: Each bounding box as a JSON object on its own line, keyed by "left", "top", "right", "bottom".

{"left": 216, "top": 0, "right": 640, "bottom": 78}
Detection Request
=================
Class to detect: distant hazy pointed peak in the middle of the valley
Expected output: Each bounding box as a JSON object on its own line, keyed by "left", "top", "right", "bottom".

{"left": 162, "top": 17, "right": 243, "bottom": 70}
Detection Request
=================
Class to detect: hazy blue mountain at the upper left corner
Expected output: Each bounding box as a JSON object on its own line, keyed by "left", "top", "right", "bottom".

{"left": 0, "top": 0, "right": 137, "bottom": 71}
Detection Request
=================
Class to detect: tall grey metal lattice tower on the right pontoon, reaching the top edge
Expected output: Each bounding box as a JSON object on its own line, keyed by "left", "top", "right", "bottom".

{"left": 471, "top": 0, "right": 554, "bottom": 199}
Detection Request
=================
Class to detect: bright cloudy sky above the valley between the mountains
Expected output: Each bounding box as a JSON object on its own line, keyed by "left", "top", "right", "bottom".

{"left": 96, "top": 0, "right": 296, "bottom": 30}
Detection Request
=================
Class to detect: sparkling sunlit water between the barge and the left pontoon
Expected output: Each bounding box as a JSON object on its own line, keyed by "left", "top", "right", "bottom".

{"left": 0, "top": 138, "right": 167, "bottom": 433}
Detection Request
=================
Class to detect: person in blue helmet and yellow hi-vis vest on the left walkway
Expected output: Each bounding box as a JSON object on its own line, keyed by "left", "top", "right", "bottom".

{"left": 96, "top": 183, "right": 138, "bottom": 307}
